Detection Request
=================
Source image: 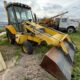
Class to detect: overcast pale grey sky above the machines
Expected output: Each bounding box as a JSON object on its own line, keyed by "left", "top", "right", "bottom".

{"left": 0, "top": 0, "right": 80, "bottom": 22}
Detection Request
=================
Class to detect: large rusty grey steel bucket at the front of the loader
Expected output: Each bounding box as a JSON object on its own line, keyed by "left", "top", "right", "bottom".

{"left": 40, "top": 43, "right": 75, "bottom": 80}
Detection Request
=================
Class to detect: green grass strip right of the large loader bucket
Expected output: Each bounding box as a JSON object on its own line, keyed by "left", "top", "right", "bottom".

{"left": 70, "top": 30, "right": 80, "bottom": 80}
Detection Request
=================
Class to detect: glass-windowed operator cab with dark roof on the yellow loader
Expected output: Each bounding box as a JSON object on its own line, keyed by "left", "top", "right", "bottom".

{"left": 6, "top": 3, "right": 35, "bottom": 32}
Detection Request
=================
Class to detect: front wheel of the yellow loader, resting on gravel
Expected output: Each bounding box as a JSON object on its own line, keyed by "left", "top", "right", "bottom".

{"left": 22, "top": 41, "right": 33, "bottom": 55}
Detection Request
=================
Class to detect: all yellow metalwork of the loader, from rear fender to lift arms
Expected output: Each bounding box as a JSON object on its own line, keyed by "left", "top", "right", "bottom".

{"left": 6, "top": 21, "right": 71, "bottom": 54}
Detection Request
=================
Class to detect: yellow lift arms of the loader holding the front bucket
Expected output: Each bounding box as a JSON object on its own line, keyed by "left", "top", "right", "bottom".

{"left": 23, "top": 21, "right": 74, "bottom": 55}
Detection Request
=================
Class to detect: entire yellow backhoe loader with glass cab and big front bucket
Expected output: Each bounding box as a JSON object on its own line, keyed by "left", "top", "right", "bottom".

{"left": 4, "top": 2, "right": 76, "bottom": 80}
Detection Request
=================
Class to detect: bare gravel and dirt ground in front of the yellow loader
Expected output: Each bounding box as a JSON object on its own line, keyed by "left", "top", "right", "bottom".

{"left": 0, "top": 46, "right": 56, "bottom": 80}
